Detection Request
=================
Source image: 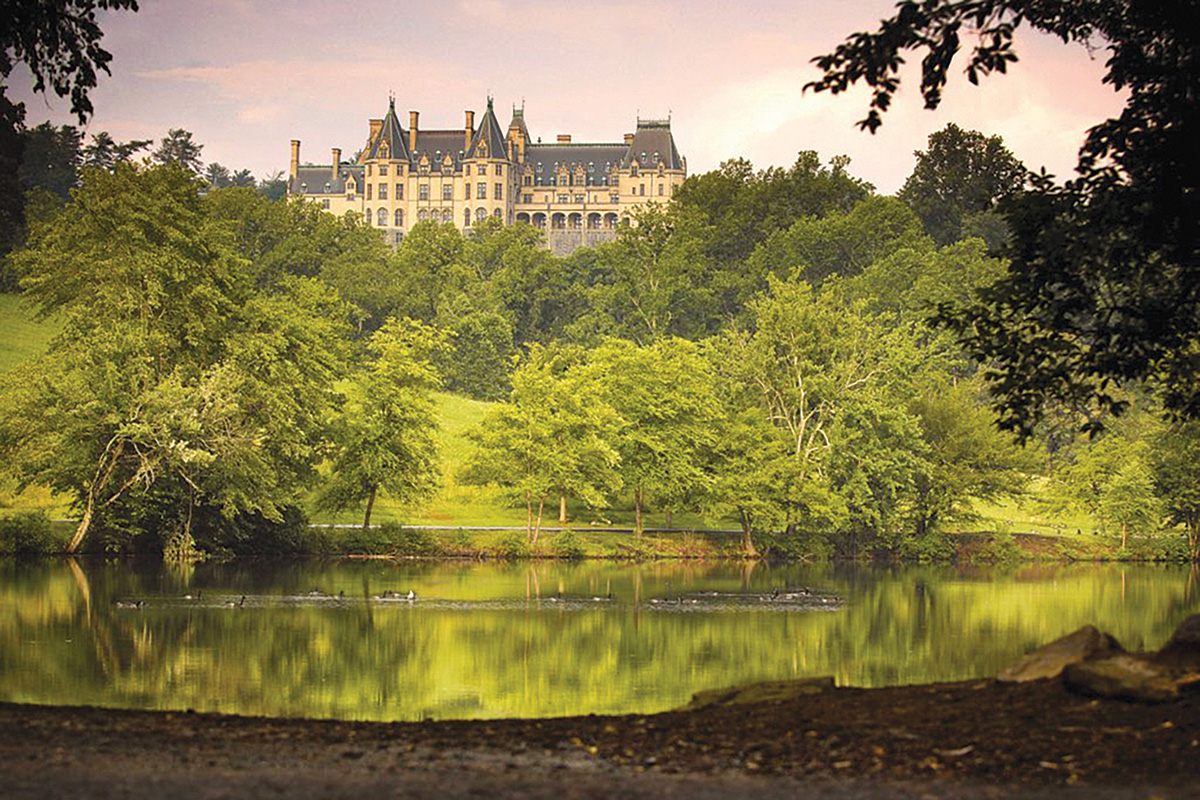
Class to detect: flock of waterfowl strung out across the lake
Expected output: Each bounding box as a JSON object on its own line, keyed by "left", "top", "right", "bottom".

{"left": 113, "top": 582, "right": 844, "bottom": 612}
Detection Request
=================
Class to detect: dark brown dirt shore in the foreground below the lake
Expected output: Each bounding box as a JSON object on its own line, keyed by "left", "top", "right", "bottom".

{"left": 0, "top": 680, "right": 1200, "bottom": 800}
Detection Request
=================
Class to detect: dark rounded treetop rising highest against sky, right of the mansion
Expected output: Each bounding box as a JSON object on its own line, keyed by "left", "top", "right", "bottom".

{"left": 896, "top": 122, "right": 1028, "bottom": 249}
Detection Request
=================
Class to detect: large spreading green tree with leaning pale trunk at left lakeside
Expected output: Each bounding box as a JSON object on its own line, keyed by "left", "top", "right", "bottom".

{"left": 0, "top": 164, "right": 347, "bottom": 549}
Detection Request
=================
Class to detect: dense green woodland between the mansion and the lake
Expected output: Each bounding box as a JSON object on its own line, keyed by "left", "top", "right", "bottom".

{"left": 0, "top": 125, "right": 1200, "bottom": 558}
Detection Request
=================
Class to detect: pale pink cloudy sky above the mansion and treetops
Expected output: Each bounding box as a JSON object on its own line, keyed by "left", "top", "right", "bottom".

{"left": 8, "top": 0, "right": 1123, "bottom": 193}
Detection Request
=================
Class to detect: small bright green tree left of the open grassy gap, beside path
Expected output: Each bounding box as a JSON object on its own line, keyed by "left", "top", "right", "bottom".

{"left": 320, "top": 320, "right": 442, "bottom": 530}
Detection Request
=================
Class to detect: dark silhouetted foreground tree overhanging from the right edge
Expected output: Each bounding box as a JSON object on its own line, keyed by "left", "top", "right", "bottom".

{"left": 808, "top": 0, "right": 1200, "bottom": 435}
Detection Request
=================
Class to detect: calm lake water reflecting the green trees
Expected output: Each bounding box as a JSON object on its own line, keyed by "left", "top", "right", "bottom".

{"left": 0, "top": 560, "right": 1200, "bottom": 720}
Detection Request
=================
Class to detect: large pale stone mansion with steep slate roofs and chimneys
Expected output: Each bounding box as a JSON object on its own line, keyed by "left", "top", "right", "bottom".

{"left": 288, "top": 97, "right": 688, "bottom": 252}
